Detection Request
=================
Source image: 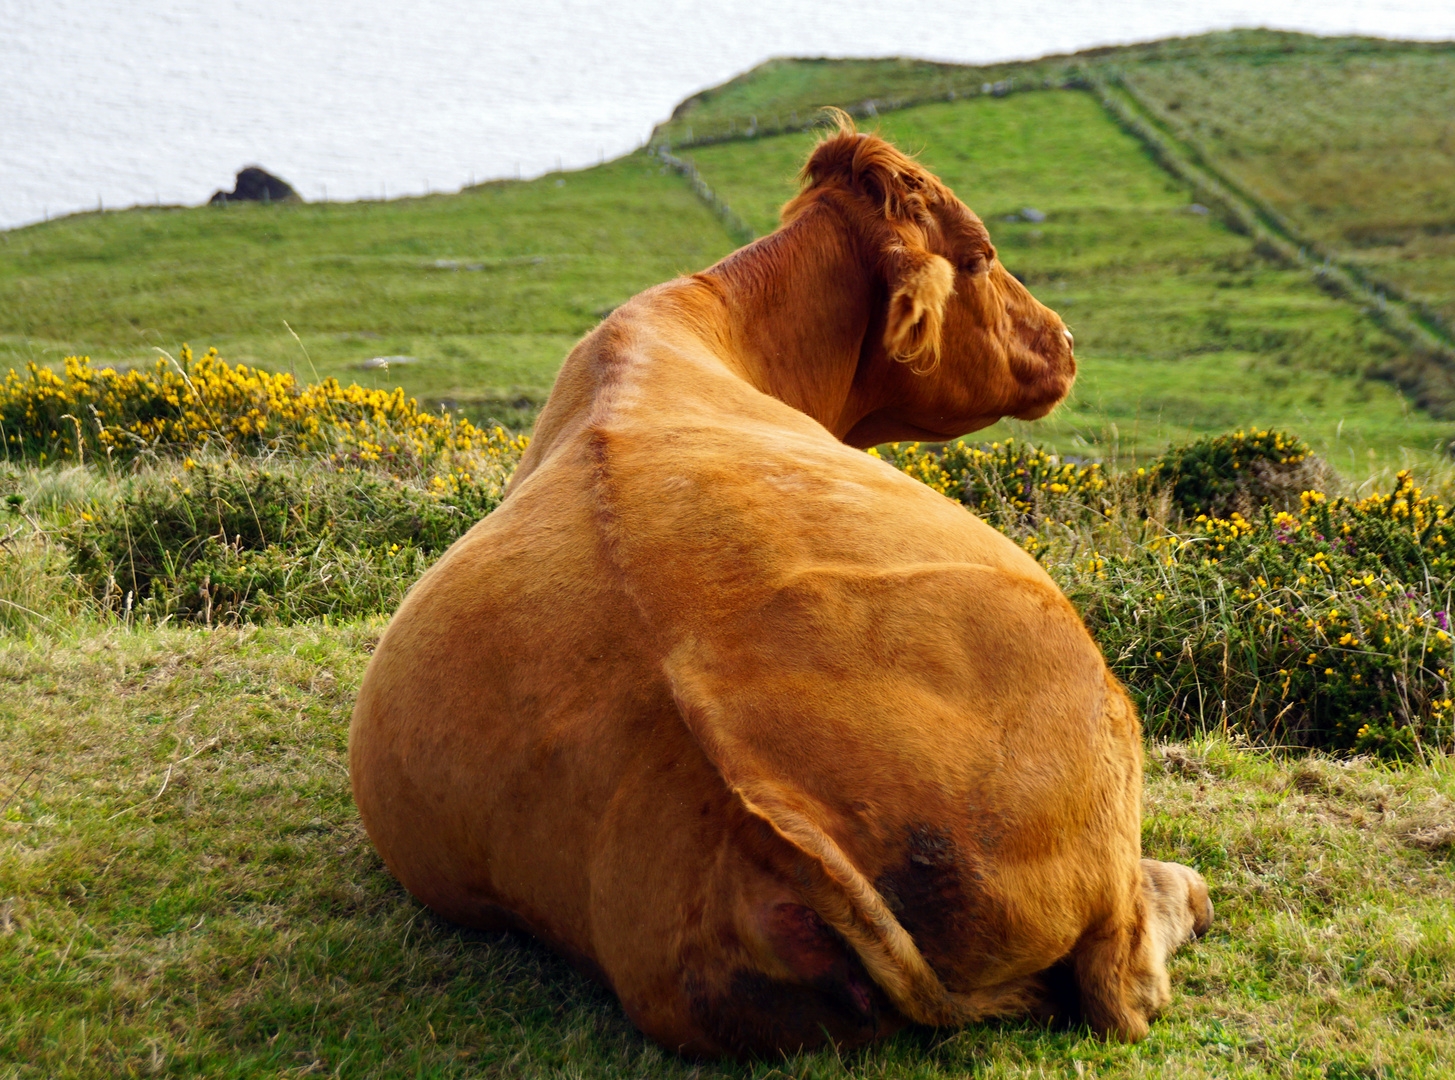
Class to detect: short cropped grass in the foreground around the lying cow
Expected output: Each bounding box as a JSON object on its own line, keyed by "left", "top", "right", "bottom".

{"left": 0, "top": 605, "right": 1455, "bottom": 1079}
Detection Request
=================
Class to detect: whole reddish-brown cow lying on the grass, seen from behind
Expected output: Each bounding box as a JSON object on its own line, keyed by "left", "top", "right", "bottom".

{"left": 349, "top": 118, "right": 1212, "bottom": 1055}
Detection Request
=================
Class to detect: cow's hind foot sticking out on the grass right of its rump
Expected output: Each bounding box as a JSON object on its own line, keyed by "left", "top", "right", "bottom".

{"left": 1072, "top": 859, "right": 1212, "bottom": 1042}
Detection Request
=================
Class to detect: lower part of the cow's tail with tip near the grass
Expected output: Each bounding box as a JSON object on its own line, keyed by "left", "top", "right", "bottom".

{"left": 735, "top": 785, "right": 1042, "bottom": 1025}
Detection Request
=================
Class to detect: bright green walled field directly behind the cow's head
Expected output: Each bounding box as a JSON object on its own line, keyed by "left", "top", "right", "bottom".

{"left": 678, "top": 90, "right": 1451, "bottom": 476}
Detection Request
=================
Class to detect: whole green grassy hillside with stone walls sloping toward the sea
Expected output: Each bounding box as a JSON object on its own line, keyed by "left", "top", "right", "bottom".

{"left": 0, "top": 32, "right": 1455, "bottom": 479}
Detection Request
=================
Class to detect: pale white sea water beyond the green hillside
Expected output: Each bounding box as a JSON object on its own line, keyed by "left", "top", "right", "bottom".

{"left": 8, "top": 0, "right": 1455, "bottom": 229}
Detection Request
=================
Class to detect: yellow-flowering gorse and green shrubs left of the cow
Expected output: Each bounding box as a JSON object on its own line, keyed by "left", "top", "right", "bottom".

{"left": 0, "top": 348, "right": 528, "bottom": 622}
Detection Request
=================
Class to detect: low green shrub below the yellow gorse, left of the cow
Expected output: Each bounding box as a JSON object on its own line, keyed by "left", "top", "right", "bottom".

{"left": 61, "top": 461, "right": 499, "bottom": 623}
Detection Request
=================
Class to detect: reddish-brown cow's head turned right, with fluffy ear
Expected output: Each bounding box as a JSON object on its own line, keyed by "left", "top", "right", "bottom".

{"left": 784, "top": 114, "right": 1077, "bottom": 445}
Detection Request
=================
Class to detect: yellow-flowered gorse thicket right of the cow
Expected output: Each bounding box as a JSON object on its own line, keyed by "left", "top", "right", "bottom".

{"left": 874, "top": 431, "right": 1455, "bottom": 757}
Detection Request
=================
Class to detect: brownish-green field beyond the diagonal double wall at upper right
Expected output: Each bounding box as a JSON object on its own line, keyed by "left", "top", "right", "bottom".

{"left": 1122, "top": 47, "right": 1455, "bottom": 327}
